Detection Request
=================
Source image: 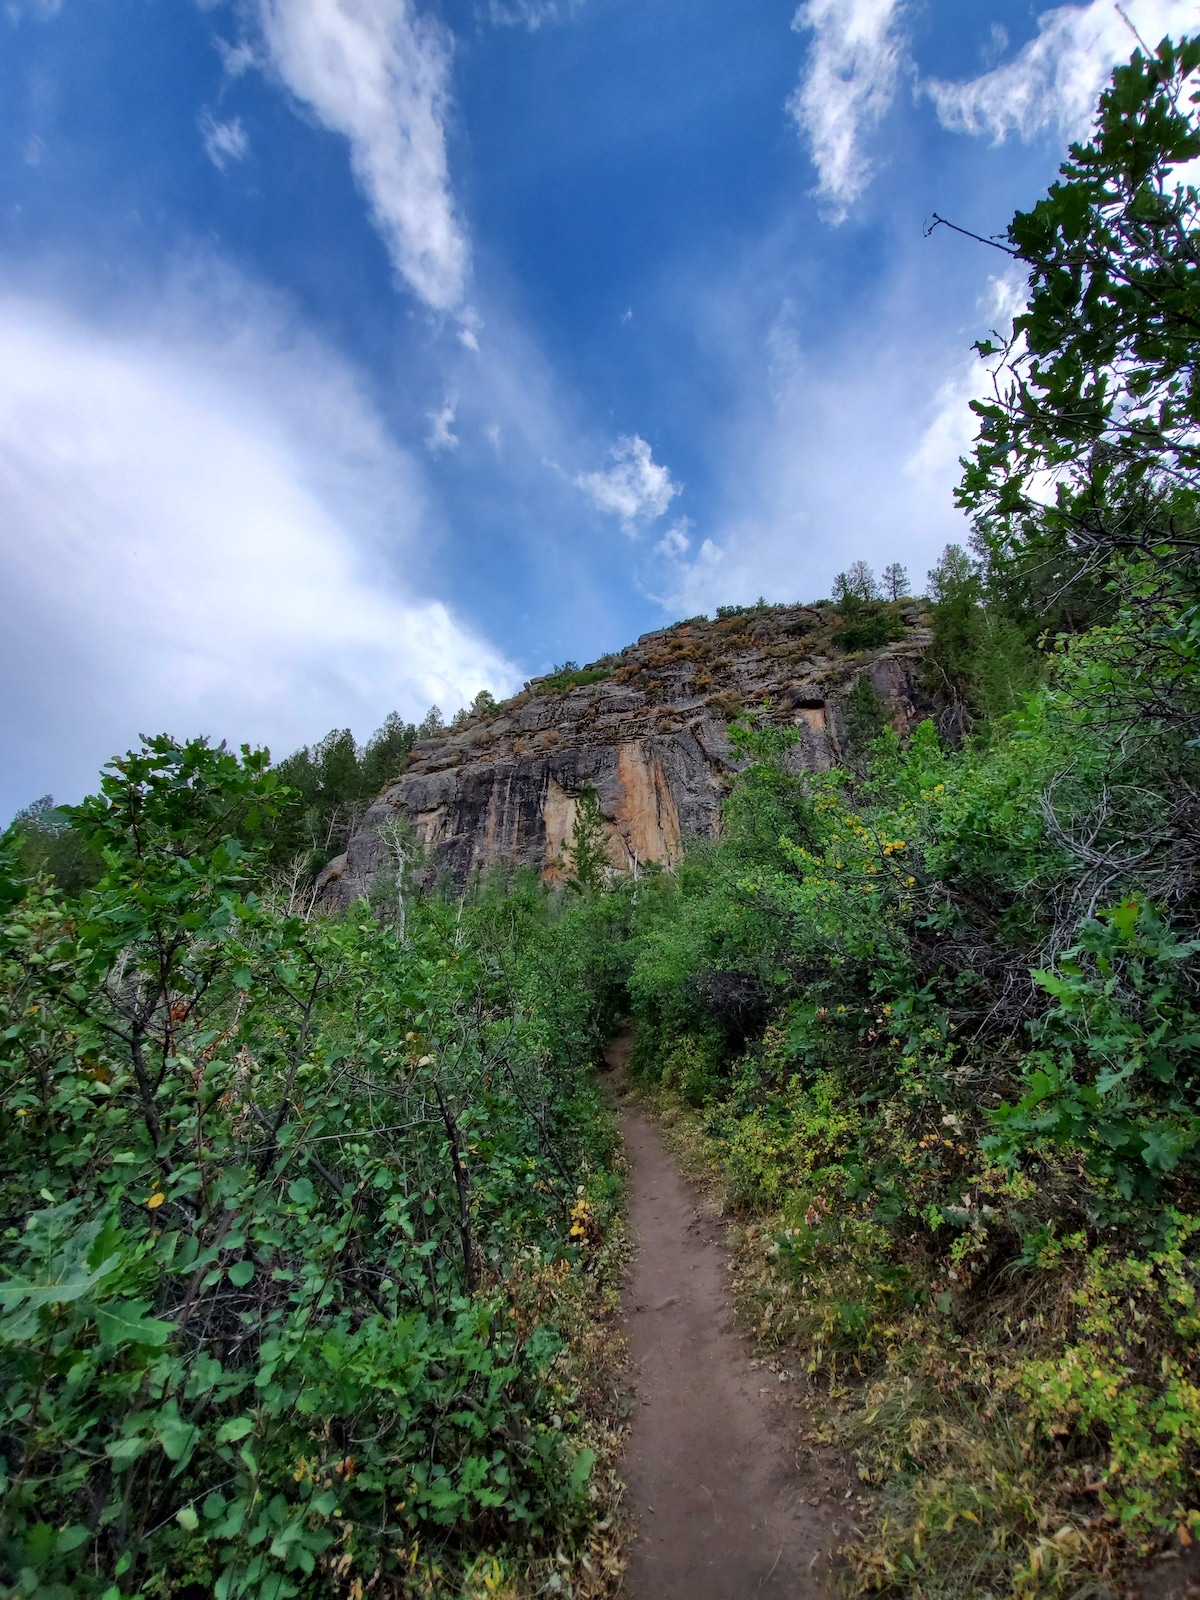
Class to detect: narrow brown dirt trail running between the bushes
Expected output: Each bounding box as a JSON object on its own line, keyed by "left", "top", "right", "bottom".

{"left": 608, "top": 1037, "right": 835, "bottom": 1600}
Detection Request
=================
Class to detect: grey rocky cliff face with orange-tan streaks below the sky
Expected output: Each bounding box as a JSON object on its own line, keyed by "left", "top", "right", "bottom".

{"left": 320, "top": 606, "right": 930, "bottom": 906}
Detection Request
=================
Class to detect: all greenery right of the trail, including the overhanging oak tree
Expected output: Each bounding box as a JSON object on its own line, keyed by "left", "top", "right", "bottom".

{"left": 629, "top": 43, "right": 1200, "bottom": 1600}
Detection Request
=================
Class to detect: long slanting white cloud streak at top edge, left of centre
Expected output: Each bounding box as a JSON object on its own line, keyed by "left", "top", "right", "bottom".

{"left": 259, "top": 0, "right": 469, "bottom": 312}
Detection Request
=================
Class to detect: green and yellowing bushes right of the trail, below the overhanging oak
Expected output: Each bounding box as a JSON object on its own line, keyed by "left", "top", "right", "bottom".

{"left": 629, "top": 684, "right": 1200, "bottom": 1600}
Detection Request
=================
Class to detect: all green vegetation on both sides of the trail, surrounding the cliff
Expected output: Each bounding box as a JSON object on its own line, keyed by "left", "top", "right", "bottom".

{"left": 0, "top": 42, "right": 1200, "bottom": 1600}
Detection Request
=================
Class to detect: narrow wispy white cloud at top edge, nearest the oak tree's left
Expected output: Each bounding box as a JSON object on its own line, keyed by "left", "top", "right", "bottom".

{"left": 787, "top": 0, "right": 904, "bottom": 222}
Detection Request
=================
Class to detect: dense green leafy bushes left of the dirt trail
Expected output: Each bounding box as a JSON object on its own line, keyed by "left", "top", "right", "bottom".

{"left": 0, "top": 739, "right": 630, "bottom": 1600}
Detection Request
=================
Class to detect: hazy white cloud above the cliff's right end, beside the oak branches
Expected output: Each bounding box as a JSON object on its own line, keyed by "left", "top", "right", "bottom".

{"left": 659, "top": 297, "right": 1000, "bottom": 616}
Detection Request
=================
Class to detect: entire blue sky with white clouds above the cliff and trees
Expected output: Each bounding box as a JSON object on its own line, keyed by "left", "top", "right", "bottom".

{"left": 0, "top": 0, "right": 1200, "bottom": 814}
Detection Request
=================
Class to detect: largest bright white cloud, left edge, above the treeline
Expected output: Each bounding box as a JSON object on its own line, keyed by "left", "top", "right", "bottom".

{"left": 0, "top": 276, "right": 518, "bottom": 813}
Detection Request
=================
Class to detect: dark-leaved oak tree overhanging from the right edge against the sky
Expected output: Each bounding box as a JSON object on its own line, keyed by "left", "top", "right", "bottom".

{"left": 958, "top": 38, "right": 1200, "bottom": 761}
